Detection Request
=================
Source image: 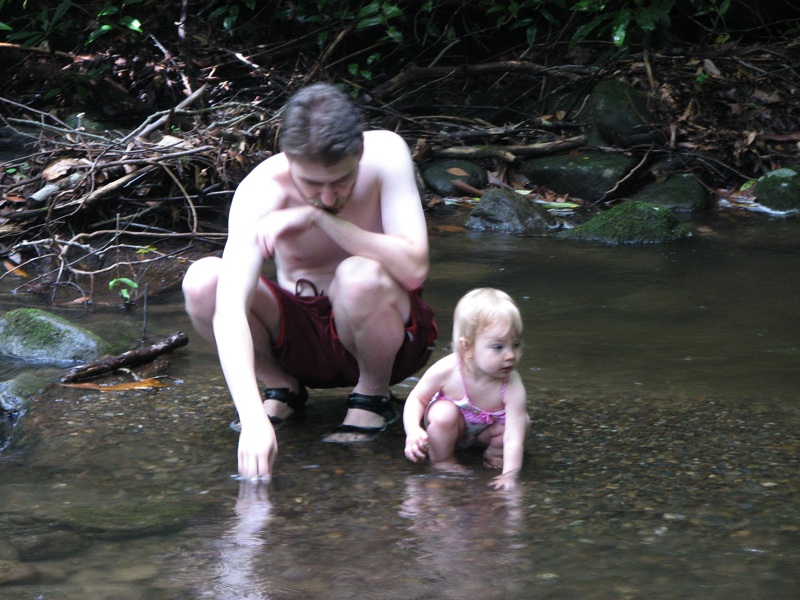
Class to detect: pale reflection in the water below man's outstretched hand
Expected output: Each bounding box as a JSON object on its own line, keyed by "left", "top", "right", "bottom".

{"left": 204, "top": 480, "right": 272, "bottom": 600}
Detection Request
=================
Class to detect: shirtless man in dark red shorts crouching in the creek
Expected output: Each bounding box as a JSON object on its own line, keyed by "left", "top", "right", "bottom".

{"left": 183, "top": 84, "right": 438, "bottom": 479}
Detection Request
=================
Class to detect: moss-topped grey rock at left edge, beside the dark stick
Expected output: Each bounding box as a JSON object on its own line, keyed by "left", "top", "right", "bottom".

{"left": 0, "top": 308, "right": 110, "bottom": 365}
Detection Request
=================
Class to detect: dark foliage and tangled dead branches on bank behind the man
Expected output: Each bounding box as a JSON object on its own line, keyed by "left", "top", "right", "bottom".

{"left": 0, "top": 0, "right": 800, "bottom": 300}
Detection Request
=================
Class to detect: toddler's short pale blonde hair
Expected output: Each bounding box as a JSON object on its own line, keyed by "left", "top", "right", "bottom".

{"left": 453, "top": 288, "right": 522, "bottom": 356}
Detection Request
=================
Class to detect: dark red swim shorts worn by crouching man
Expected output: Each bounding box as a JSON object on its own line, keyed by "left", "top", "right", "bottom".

{"left": 264, "top": 279, "right": 439, "bottom": 388}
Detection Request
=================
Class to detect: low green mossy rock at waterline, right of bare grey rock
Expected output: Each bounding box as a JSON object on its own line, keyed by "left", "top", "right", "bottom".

{"left": 556, "top": 200, "right": 691, "bottom": 246}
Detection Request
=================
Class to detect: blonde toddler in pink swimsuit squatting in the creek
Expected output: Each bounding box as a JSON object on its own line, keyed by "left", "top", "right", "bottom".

{"left": 403, "top": 288, "right": 530, "bottom": 489}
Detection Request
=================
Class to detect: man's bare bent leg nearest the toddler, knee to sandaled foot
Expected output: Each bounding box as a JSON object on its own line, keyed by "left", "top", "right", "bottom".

{"left": 330, "top": 257, "right": 411, "bottom": 441}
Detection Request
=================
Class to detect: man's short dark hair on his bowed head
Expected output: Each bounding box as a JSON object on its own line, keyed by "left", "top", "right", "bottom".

{"left": 280, "top": 83, "right": 363, "bottom": 165}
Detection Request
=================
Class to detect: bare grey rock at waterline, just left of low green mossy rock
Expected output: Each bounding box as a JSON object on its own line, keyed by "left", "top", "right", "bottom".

{"left": 465, "top": 189, "right": 558, "bottom": 234}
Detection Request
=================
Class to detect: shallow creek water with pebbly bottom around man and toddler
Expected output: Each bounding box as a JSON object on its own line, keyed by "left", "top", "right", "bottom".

{"left": 0, "top": 220, "right": 800, "bottom": 600}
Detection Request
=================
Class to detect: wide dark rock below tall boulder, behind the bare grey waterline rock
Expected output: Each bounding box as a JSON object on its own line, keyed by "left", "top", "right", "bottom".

{"left": 519, "top": 151, "right": 638, "bottom": 202}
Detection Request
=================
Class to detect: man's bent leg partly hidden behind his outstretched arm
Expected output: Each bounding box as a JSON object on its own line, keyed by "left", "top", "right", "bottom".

{"left": 183, "top": 257, "right": 299, "bottom": 418}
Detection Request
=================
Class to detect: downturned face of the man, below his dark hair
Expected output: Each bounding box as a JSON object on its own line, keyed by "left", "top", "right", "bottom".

{"left": 289, "top": 152, "right": 361, "bottom": 214}
